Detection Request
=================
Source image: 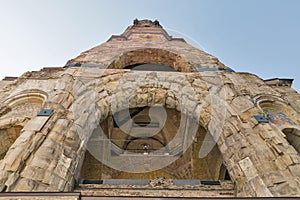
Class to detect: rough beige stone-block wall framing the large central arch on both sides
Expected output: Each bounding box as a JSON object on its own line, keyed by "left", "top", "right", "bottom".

{"left": 0, "top": 68, "right": 300, "bottom": 196}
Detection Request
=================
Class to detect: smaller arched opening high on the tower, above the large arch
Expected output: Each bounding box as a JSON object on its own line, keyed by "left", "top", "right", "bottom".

{"left": 108, "top": 48, "right": 192, "bottom": 72}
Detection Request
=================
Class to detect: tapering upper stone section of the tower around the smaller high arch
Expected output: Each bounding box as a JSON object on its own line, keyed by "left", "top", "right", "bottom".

{"left": 67, "top": 21, "right": 227, "bottom": 72}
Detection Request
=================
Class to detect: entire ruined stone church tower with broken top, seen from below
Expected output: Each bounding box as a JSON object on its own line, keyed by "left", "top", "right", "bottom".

{"left": 0, "top": 19, "right": 300, "bottom": 199}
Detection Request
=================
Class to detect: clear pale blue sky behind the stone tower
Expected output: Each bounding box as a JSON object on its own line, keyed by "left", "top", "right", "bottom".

{"left": 0, "top": 0, "right": 300, "bottom": 91}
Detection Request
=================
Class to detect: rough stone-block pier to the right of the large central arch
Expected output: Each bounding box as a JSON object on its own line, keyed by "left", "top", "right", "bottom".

{"left": 219, "top": 73, "right": 299, "bottom": 196}
